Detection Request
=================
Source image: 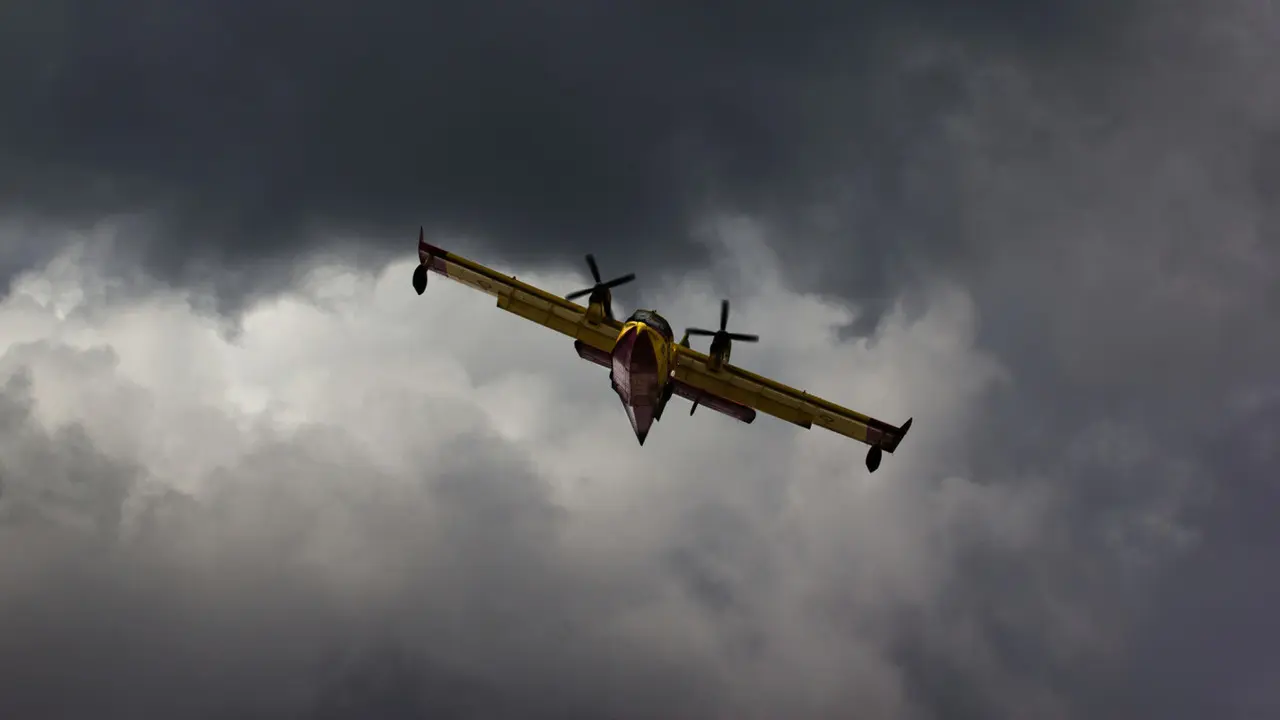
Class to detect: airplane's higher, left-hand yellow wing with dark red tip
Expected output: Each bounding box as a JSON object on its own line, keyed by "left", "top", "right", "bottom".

{"left": 413, "top": 229, "right": 622, "bottom": 352}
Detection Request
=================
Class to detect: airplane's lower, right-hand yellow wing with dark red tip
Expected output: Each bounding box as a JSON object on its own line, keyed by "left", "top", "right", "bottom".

{"left": 676, "top": 346, "right": 911, "bottom": 464}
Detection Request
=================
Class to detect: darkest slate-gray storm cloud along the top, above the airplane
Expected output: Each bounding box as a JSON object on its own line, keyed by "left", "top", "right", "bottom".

{"left": 0, "top": 0, "right": 1125, "bottom": 296}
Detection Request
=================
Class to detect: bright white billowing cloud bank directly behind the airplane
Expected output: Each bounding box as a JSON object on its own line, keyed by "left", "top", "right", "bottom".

{"left": 0, "top": 224, "right": 1198, "bottom": 717}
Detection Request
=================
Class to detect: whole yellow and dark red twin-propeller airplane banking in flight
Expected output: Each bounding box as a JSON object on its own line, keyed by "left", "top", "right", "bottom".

{"left": 413, "top": 227, "right": 911, "bottom": 473}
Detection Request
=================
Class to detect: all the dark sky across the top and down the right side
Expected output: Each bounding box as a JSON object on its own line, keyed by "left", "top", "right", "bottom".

{"left": 0, "top": 0, "right": 1280, "bottom": 717}
